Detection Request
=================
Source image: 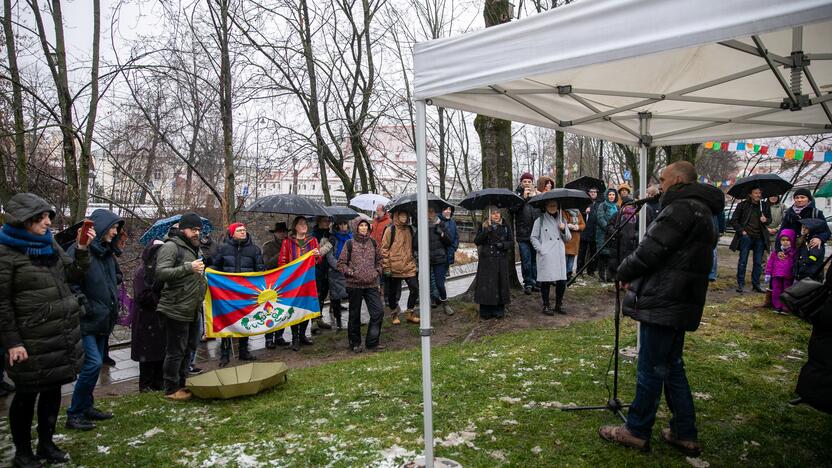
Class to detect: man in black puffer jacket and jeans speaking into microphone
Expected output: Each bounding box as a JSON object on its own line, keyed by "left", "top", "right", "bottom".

{"left": 598, "top": 161, "right": 725, "bottom": 456}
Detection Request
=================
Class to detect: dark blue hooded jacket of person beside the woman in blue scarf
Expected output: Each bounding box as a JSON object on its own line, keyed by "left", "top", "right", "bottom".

{"left": 67, "top": 209, "right": 124, "bottom": 336}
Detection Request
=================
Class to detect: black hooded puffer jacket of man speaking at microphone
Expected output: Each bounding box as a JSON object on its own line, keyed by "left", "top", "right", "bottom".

{"left": 617, "top": 183, "right": 725, "bottom": 331}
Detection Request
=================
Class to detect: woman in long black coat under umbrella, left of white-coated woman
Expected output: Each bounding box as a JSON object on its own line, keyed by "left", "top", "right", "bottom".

{"left": 474, "top": 206, "right": 514, "bottom": 320}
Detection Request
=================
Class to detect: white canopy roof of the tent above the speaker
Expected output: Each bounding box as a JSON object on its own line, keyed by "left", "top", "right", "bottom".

{"left": 414, "top": 0, "right": 832, "bottom": 145}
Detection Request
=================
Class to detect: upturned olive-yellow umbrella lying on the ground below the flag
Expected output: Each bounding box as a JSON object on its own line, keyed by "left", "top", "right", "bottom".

{"left": 185, "top": 362, "right": 289, "bottom": 399}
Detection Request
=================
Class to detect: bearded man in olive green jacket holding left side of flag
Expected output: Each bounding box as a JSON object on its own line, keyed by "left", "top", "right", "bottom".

{"left": 156, "top": 212, "right": 206, "bottom": 401}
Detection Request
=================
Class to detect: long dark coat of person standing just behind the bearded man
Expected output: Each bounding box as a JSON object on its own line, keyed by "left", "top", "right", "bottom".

{"left": 130, "top": 243, "right": 165, "bottom": 362}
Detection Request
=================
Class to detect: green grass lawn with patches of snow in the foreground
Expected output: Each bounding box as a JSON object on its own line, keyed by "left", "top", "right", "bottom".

{"left": 0, "top": 288, "right": 832, "bottom": 467}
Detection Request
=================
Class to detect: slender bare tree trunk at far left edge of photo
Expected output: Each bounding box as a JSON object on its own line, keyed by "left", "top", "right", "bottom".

{"left": 3, "top": 0, "right": 29, "bottom": 192}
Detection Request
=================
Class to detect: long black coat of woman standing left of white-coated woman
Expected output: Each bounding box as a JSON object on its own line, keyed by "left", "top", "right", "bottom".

{"left": 474, "top": 222, "right": 514, "bottom": 305}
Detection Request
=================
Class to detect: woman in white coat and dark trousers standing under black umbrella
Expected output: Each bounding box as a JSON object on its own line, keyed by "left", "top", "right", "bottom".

{"left": 530, "top": 200, "right": 572, "bottom": 315}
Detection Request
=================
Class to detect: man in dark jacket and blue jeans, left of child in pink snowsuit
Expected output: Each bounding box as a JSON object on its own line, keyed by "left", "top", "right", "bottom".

{"left": 730, "top": 187, "right": 770, "bottom": 293}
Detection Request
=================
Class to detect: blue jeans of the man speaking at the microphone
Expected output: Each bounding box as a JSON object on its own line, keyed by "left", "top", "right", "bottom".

{"left": 626, "top": 323, "right": 697, "bottom": 440}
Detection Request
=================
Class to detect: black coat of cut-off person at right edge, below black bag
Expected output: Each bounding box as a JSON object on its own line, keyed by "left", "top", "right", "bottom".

{"left": 797, "top": 268, "right": 832, "bottom": 414}
